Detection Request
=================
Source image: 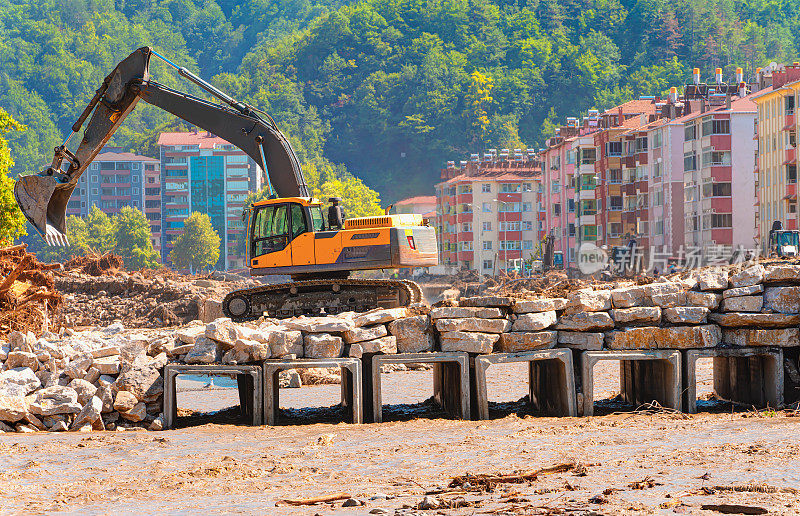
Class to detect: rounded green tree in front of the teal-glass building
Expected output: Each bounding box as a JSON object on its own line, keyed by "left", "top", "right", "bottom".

{"left": 169, "top": 211, "right": 220, "bottom": 272}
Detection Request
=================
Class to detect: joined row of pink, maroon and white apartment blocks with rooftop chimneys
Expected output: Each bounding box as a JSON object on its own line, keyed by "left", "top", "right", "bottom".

{"left": 540, "top": 69, "right": 760, "bottom": 270}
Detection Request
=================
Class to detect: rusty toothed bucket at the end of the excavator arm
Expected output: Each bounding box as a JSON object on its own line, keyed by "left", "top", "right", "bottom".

{"left": 14, "top": 172, "right": 75, "bottom": 246}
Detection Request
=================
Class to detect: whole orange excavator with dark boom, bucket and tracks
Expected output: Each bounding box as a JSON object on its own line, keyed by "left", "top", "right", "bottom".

{"left": 14, "top": 47, "right": 438, "bottom": 321}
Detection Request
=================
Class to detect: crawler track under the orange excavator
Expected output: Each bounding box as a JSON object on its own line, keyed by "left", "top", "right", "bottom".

{"left": 222, "top": 279, "right": 422, "bottom": 322}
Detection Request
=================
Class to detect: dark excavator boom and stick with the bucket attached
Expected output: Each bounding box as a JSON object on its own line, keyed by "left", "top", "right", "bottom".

{"left": 14, "top": 47, "right": 308, "bottom": 245}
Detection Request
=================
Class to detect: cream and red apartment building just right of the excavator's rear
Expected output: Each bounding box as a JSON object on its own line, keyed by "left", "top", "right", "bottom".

{"left": 435, "top": 156, "right": 545, "bottom": 274}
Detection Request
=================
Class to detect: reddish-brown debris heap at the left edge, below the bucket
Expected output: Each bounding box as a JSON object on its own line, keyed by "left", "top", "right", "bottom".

{"left": 0, "top": 244, "right": 62, "bottom": 336}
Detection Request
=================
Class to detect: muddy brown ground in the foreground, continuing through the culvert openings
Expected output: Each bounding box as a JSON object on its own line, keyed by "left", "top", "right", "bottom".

{"left": 0, "top": 365, "right": 800, "bottom": 515}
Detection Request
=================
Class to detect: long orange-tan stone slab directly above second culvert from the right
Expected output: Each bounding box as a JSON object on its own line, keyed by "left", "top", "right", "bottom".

{"left": 605, "top": 324, "right": 722, "bottom": 349}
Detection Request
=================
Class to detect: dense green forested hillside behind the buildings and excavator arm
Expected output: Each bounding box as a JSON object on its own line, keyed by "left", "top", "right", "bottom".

{"left": 0, "top": 0, "right": 800, "bottom": 203}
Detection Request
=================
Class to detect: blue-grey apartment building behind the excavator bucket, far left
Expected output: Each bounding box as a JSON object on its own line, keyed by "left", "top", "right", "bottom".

{"left": 67, "top": 147, "right": 161, "bottom": 250}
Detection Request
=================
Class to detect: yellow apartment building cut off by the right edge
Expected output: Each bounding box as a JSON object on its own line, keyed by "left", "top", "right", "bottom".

{"left": 752, "top": 63, "right": 800, "bottom": 253}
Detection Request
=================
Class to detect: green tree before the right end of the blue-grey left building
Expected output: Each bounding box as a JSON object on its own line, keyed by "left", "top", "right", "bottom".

{"left": 113, "top": 206, "right": 159, "bottom": 269}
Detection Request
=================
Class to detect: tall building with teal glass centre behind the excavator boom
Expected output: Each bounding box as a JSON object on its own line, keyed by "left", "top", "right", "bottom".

{"left": 158, "top": 132, "right": 262, "bottom": 270}
